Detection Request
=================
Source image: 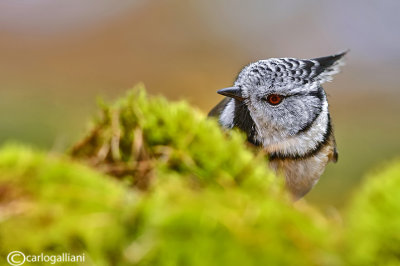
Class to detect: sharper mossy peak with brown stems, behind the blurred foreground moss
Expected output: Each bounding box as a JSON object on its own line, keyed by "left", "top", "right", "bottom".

{"left": 71, "top": 88, "right": 275, "bottom": 192}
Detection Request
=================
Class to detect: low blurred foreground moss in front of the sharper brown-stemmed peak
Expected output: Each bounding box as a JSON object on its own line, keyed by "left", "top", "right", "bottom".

{"left": 0, "top": 146, "right": 337, "bottom": 265}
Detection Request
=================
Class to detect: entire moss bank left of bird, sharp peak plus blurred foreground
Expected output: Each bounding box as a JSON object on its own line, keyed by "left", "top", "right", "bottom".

{"left": 0, "top": 87, "right": 340, "bottom": 265}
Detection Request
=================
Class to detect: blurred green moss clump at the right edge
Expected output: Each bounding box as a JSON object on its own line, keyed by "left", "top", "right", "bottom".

{"left": 343, "top": 160, "right": 400, "bottom": 265}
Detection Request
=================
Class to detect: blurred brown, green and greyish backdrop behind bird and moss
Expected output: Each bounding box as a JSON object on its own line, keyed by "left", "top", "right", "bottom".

{"left": 0, "top": 0, "right": 400, "bottom": 210}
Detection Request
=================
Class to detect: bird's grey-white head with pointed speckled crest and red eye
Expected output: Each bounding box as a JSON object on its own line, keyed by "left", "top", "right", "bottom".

{"left": 218, "top": 50, "right": 345, "bottom": 143}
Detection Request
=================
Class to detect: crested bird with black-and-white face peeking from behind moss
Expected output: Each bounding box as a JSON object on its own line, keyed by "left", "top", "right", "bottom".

{"left": 208, "top": 51, "right": 347, "bottom": 200}
